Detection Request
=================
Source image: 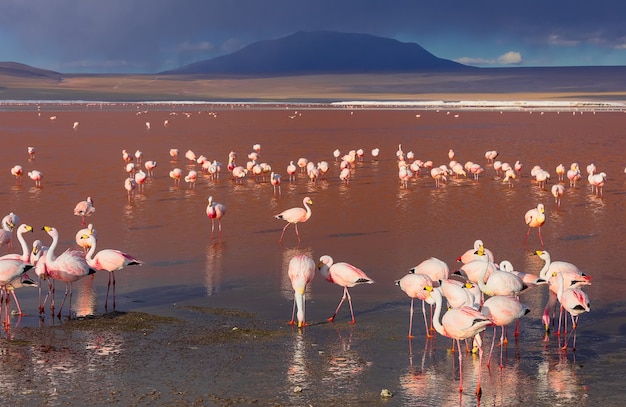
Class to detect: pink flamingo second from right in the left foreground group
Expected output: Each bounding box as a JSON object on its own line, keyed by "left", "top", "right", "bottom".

{"left": 43, "top": 226, "right": 96, "bottom": 318}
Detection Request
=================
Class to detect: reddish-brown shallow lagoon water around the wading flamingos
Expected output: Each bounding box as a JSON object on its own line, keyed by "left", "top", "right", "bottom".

{"left": 0, "top": 104, "right": 626, "bottom": 405}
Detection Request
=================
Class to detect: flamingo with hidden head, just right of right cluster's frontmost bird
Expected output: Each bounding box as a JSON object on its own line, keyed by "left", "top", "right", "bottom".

{"left": 480, "top": 295, "right": 530, "bottom": 368}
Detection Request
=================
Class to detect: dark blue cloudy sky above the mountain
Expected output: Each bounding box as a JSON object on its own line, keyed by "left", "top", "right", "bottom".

{"left": 0, "top": 0, "right": 626, "bottom": 73}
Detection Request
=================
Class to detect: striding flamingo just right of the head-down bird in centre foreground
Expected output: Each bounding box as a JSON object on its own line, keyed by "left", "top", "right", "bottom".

{"left": 317, "top": 254, "right": 374, "bottom": 324}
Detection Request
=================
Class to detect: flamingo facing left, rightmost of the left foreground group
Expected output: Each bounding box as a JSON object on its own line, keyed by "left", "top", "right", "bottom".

{"left": 81, "top": 234, "right": 144, "bottom": 311}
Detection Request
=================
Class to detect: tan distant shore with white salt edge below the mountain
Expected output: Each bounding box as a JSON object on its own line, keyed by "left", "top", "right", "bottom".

{"left": 0, "top": 67, "right": 626, "bottom": 107}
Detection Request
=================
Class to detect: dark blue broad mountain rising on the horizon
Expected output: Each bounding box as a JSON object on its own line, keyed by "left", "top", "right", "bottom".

{"left": 161, "top": 31, "right": 473, "bottom": 76}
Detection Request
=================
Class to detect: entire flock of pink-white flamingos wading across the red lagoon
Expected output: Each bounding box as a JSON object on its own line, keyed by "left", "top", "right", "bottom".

{"left": 0, "top": 124, "right": 626, "bottom": 394}
